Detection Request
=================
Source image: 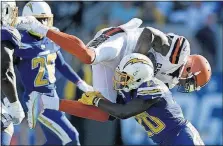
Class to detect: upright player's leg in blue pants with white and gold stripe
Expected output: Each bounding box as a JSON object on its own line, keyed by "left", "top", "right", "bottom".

{"left": 38, "top": 110, "right": 79, "bottom": 145}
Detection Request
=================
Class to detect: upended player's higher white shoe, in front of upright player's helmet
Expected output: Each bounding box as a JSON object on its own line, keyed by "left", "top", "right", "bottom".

{"left": 15, "top": 16, "right": 49, "bottom": 36}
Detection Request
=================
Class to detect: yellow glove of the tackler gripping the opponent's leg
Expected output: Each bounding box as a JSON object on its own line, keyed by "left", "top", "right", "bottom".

{"left": 78, "top": 91, "right": 100, "bottom": 105}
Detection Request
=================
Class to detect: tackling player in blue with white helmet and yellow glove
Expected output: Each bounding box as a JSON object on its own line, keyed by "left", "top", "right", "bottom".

{"left": 79, "top": 53, "right": 206, "bottom": 145}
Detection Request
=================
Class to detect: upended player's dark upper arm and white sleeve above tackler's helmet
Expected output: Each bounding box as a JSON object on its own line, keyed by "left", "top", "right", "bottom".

{"left": 137, "top": 27, "right": 170, "bottom": 56}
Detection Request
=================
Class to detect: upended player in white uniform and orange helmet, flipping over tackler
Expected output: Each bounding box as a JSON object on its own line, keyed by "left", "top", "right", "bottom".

{"left": 18, "top": 17, "right": 211, "bottom": 102}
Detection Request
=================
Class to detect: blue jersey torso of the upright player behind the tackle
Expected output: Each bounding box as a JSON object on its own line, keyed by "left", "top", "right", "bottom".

{"left": 15, "top": 31, "right": 59, "bottom": 93}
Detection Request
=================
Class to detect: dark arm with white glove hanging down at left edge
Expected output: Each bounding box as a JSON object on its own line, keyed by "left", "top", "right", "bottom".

{"left": 1, "top": 41, "right": 25, "bottom": 124}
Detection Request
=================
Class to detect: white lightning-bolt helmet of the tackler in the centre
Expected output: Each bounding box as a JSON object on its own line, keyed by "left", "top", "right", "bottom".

{"left": 113, "top": 53, "right": 154, "bottom": 92}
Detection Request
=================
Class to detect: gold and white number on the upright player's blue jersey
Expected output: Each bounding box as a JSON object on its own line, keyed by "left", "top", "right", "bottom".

{"left": 32, "top": 53, "right": 57, "bottom": 87}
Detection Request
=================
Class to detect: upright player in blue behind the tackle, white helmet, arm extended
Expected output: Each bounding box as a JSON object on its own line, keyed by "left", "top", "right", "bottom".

{"left": 12, "top": 1, "right": 93, "bottom": 145}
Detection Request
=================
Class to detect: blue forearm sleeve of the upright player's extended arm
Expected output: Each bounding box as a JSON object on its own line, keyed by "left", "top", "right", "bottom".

{"left": 56, "top": 51, "right": 81, "bottom": 84}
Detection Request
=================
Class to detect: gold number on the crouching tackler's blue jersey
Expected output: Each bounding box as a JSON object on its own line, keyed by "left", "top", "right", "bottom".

{"left": 135, "top": 112, "right": 166, "bottom": 137}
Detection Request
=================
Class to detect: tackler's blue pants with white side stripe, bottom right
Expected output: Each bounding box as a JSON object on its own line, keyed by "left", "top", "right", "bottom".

{"left": 173, "top": 122, "right": 204, "bottom": 146}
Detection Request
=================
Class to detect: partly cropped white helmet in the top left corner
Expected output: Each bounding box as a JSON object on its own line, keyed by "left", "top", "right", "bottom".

{"left": 1, "top": 0, "right": 18, "bottom": 26}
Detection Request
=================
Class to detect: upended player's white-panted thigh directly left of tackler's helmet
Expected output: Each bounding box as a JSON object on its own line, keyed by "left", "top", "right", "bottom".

{"left": 92, "top": 64, "right": 117, "bottom": 102}
